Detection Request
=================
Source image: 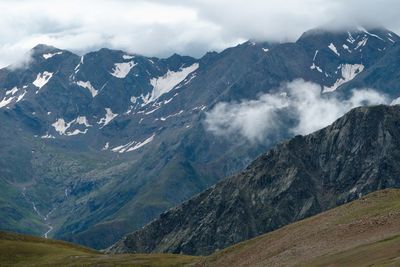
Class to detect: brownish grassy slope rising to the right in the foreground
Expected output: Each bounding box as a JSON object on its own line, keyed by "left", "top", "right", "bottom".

{"left": 199, "top": 189, "right": 400, "bottom": 266}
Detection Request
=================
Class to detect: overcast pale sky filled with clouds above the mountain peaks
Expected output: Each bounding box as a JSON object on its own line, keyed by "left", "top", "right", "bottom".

{"left": 0, "top": 0, "right": 400, "bottom": 67}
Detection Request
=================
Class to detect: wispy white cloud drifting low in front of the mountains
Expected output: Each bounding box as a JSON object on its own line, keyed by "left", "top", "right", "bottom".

{"left": 205, "top": 80, "right": 390, "bottom": 143}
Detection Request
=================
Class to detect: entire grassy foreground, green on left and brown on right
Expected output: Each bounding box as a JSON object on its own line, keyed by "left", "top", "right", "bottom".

{"left": 0, "top": 189, "right": 400, "bottom": 267}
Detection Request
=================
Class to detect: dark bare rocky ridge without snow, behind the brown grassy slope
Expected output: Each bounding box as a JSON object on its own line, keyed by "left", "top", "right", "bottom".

{"left": 109, "top": 105, "right": 400, "bottom": 255}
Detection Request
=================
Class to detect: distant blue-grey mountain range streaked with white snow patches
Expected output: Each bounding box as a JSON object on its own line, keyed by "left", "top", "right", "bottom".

{"left": 0, "top": 28, "right": 400, "bottom": 248}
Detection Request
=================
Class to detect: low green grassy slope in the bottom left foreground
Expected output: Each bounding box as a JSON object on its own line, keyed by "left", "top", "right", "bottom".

{"left": 0, "top": 232, "right": 198, "bottom": 267}
